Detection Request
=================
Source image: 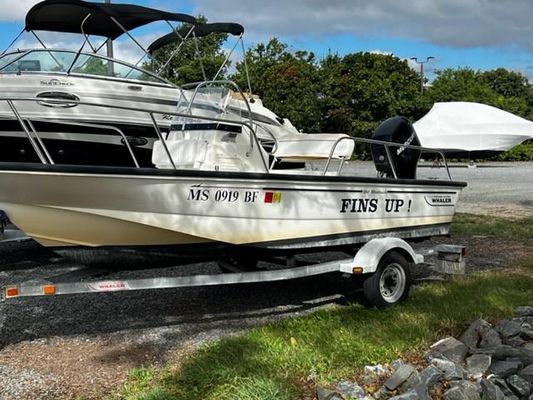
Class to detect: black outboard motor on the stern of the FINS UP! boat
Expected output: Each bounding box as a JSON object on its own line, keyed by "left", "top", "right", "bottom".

{"left": 370, "top": 117, "right": 421, "bottom": 179}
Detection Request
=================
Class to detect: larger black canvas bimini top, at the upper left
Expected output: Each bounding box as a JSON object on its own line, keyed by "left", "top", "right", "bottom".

{"left": 25, "top": 0, "right": 197, "bottom": 39}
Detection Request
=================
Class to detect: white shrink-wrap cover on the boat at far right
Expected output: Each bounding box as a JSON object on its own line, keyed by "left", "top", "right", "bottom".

{"left": 414, "top": 102, "right": 533, "bottom": 152}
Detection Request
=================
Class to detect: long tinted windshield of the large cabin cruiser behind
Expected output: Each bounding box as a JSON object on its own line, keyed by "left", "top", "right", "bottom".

{"left": 0, "top": 49, "right": 167, "bottom": 83}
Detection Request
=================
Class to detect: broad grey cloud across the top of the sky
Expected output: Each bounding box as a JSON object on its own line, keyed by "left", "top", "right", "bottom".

{"left": 195, "top": 0, "right": 533, "bottom": 49}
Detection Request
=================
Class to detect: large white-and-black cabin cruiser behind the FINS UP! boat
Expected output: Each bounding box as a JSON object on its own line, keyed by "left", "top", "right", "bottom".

{"left": 0, "top": 0, "right": 306, "bottom": 167}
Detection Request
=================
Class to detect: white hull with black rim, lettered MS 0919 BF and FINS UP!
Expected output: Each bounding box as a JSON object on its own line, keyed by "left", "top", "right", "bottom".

{"left": 0, "top": 164, "right": 464, "bottom": 249}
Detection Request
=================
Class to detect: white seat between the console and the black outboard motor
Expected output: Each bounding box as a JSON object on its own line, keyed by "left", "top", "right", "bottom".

{"left": 273, "top": 133, "right": 355, "bottom": 160}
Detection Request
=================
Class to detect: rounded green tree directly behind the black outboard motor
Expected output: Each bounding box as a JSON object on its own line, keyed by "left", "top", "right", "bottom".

{"left": 320, "top": 52, "right": 424, "bottom": 137}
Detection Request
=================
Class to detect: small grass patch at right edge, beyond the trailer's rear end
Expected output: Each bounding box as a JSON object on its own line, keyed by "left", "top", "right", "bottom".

{"left": 450, "top": 213, "right": 533, "bottom": 240}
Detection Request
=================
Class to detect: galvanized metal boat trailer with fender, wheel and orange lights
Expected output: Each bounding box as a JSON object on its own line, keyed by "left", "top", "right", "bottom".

{"left": 1, "top": 237, "right": 465, "bottom": 308}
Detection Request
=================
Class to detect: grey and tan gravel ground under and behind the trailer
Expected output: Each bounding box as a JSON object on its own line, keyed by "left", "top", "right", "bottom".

{"left": 0, "top": 163, "right": 533, "bottom": 400}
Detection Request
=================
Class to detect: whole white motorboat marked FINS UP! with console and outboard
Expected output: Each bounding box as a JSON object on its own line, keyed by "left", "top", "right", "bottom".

{"left": 0, "top": 81, "right": 466, "bottom": 254}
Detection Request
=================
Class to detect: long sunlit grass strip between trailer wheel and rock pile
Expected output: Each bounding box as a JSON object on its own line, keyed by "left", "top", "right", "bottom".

{"left": 110, "top": 269, "right": 533, "bottom": 400}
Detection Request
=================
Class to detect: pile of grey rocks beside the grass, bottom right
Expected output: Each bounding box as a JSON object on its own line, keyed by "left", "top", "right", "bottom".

{"left": 317, "top": 307, "right": 533, "bottom": 400}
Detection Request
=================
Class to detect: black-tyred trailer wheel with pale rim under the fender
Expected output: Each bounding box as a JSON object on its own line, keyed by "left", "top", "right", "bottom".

{"left": 363, "top": 250, "right": 411, "bottom": 308}
